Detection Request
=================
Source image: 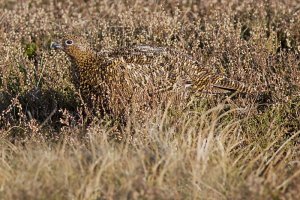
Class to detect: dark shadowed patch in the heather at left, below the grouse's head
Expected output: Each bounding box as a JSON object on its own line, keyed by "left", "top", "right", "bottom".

{"left": 0, "top": 88, "right": 80, "bottom": 131}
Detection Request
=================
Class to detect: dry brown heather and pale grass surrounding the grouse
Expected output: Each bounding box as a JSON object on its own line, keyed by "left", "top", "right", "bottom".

{"left": 0, "top": 0, "right": 300, "bottom": 199}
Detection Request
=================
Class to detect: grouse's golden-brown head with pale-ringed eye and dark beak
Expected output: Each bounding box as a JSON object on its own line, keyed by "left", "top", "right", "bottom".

{"left": 50, "top": 35, "right": 93, "bottom": 60}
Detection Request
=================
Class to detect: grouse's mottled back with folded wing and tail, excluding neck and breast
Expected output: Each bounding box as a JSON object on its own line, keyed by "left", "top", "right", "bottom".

{"left": 97, "top": 45, "right": 255, "bottom": 95}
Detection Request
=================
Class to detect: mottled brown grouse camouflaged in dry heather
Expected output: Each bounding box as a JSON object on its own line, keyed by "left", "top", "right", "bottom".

{"left": 51, "top": 35, "right": 256, "bottom": 121}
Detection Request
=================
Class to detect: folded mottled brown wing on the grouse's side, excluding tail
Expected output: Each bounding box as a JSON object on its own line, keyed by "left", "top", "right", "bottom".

{"left": 97, "top": 45, "right": 183, "bottom": 92}
